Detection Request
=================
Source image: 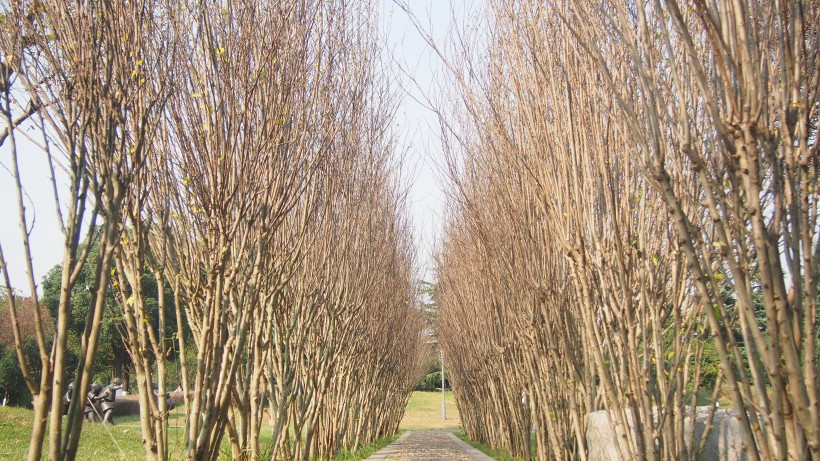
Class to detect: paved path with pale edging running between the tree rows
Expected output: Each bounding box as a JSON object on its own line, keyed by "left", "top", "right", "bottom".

{"left": 365, "top": 431, "right": 493, "bottom": 461}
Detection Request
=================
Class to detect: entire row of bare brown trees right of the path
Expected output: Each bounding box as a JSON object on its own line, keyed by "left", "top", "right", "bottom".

{"left": 437, "top": 0, "right": 820, "bottom": 460}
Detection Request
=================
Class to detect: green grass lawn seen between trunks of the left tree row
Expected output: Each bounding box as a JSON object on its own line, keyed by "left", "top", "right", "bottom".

{"left": 0, "top": 407, "right": 396, "bottom": 461}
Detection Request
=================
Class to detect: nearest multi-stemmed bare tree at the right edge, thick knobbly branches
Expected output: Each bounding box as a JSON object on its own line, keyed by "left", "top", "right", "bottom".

{"left": 567, "top": 1, "right": 820, "bottom": 459}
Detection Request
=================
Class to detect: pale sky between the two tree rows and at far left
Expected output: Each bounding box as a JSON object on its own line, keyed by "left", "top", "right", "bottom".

{"left": 0, "top": 0, "right": 482, "bottom": 293}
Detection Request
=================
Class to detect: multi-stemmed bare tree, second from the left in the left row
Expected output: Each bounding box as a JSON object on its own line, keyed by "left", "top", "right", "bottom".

{"left": 155, "top": 2, "right": 332, "bottom": 459}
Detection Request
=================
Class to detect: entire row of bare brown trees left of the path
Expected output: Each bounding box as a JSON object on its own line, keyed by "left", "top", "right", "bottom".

{"left": 0, "top": 0, "right": 423, "bottom": 460}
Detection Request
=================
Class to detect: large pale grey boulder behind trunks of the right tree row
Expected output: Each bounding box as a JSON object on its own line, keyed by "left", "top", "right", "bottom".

{"left": 586, "top": 407, "right": 747, "bottom": 461}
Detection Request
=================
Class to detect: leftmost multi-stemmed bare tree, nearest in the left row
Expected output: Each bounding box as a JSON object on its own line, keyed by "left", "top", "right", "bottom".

{"left": 2, "top": 2, "right": 168, "bottom": 460}
